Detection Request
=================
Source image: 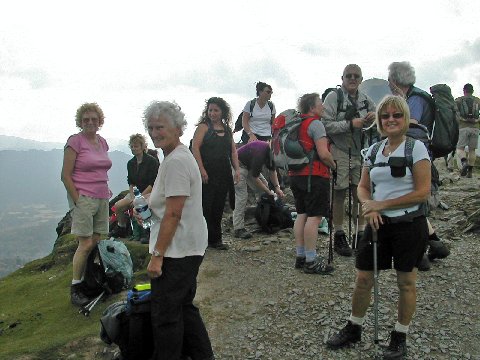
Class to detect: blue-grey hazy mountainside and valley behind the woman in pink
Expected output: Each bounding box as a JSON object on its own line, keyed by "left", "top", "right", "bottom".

{"left": 0, "top": 145, "right": 132, "bottom": 277}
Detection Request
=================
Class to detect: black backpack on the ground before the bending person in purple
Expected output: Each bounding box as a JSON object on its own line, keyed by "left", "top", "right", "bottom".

{"left": 255, "top": 193, "right": 294, "bottom": 234}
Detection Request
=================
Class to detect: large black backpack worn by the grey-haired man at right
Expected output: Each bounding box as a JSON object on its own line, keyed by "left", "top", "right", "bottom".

{"left": 407, "top": 84, "right": 459, "bottom": 159}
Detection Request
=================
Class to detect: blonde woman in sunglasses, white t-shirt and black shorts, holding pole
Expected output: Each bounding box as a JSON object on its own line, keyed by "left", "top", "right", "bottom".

{"left": 327, "top": 95, "right": 431, "bottom": 359}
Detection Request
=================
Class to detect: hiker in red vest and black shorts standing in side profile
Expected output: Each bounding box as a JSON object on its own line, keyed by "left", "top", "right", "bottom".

{"left": 288, "top": 93, "right": 336, "bottom": 274}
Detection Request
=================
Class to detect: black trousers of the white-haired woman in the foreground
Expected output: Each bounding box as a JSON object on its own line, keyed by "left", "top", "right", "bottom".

{"left": 151, "top": 256, "right": 213, "bottom": 360}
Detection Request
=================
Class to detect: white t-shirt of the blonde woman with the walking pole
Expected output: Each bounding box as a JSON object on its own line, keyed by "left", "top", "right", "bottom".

{"left": 365, "top": 139, "right": 430, "bottom": 217}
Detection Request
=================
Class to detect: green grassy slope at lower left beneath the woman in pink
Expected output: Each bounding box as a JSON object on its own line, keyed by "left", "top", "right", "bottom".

{"left": 0, "top": 235, "right": 148, "bottom": 360}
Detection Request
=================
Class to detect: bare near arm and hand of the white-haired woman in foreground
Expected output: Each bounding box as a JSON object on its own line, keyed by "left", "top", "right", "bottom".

{"left": 147, "top": 196, "right": 187, "bottom": 278}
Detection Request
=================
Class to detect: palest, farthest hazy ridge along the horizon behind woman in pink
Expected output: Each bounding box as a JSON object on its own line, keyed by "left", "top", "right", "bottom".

{"left": 0, "top": 135, "right": 131, "bottom": 155}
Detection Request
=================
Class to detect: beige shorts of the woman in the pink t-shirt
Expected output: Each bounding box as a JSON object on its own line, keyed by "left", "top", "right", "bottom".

{"left": 71, "top": 195, "right": 109, "bottom": 237}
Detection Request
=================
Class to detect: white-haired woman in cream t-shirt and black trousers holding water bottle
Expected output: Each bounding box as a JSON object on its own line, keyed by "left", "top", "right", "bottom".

{"left": 137, "top": 101, "right": 214, "bottom": 360}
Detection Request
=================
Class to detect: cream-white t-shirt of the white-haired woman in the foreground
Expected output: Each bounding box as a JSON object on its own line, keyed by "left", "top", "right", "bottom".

{"left": 149, "top": 144, "right": 208, "bottom": 258}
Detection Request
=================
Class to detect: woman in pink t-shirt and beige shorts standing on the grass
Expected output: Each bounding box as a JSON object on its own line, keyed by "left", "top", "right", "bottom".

{"left": 62, "top": 103, "right": 112, "bottom": 306}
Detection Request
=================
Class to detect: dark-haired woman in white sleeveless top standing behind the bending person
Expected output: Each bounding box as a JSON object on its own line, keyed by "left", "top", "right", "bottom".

{"left": 242, "top": 81, "right": 276, "bottom": 144}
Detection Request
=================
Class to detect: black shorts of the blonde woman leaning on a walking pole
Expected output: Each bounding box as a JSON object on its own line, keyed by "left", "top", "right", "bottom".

{"left": 355, "top": 216, "right": 428, "bottom": 272}
